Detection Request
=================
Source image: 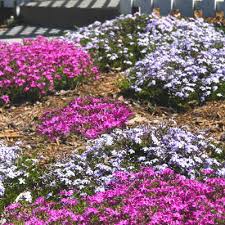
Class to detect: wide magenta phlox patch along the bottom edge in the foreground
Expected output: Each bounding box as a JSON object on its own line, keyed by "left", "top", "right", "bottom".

{"left": 4, "top": 168, "right": 225, "bottom": 225}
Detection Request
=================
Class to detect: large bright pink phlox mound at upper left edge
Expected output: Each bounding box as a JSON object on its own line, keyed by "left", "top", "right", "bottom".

{"left": 0, "top": 37, "right": 98, "bottom": 104}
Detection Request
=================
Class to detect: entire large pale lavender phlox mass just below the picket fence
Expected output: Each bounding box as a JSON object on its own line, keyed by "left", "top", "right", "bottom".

{"left": 67, "top": 14, "right": 225, "bottom": 109}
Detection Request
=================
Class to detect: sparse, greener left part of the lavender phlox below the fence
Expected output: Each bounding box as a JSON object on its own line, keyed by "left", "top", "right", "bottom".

{"left": 64, "top": 14, "right": 153, "bottom": 70}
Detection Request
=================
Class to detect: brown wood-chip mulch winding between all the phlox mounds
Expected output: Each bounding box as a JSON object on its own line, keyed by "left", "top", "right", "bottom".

{"left": 0, "top": 73, "right": 225, "bottom": 163}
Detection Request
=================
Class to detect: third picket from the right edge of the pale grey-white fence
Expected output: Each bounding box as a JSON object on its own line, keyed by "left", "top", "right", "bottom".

{"left": 174, "top": 0, "right": 195, "bottom": 17}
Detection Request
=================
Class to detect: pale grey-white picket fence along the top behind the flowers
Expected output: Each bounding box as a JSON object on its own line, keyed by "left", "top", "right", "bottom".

{"left": 0, "top": 0, "right": 225, "bottom": 17}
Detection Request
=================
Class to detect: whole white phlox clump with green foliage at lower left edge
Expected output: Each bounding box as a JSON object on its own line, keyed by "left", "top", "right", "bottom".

{"left": 0, "top": 141, "right": 42, "bottom": 212}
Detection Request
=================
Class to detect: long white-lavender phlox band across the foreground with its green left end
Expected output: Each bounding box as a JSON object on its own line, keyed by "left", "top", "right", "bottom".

{"left": 0, "top": 126, "right": 225, "bottom": 215}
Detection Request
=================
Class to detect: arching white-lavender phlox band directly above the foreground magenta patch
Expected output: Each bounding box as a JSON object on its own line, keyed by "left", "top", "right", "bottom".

{"left": 43, "top": 126, "right": 225, "bottom": 194}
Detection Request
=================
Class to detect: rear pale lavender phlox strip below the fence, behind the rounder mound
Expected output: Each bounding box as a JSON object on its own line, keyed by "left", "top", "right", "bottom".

{"left": 65, "top": 14, "right": 224, "bottom": 74}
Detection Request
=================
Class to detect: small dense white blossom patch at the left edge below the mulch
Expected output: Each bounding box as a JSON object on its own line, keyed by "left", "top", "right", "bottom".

{"left": 0, "top": 142, "right": 21, "bottom": 197}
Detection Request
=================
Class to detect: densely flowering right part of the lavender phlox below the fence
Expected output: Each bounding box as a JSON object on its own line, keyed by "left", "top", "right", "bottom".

{"left": 127, "top": 17, "right": 225, "bottom": 106}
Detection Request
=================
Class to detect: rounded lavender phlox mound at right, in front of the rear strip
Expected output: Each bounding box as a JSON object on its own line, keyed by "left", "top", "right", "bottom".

{"left": 128, "top": 40, "right": 225, "bottom": 108}
